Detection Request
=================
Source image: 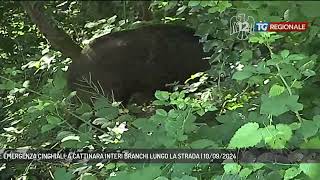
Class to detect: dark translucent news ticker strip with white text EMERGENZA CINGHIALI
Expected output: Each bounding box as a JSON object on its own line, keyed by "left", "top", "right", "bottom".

{"left": 0, "top": 149, "right": 320, "bottom": 164}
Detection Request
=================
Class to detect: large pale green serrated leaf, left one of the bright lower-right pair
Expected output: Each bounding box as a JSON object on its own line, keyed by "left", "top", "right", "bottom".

{"left": 228, "top": 123, "right": 262, "bottom": 148}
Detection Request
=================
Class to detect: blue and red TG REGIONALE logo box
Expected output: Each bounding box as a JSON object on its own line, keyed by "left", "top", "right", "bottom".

{"left": 254, "top": 22, "right": 308, "bottom": 32}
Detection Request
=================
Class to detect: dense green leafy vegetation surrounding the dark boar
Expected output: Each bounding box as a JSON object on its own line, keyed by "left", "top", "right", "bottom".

{"left": 0, "top": 1, "right": 320, "bottom": 180}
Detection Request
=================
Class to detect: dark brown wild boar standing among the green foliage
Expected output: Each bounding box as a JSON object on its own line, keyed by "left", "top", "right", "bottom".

{"left": 69, "top": 25, "right": 209, "bottom": 102}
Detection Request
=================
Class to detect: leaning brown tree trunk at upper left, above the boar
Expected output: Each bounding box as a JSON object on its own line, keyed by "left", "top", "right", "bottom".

{"left": 20, "top": 1, "right": 82, "bottom": 59}
